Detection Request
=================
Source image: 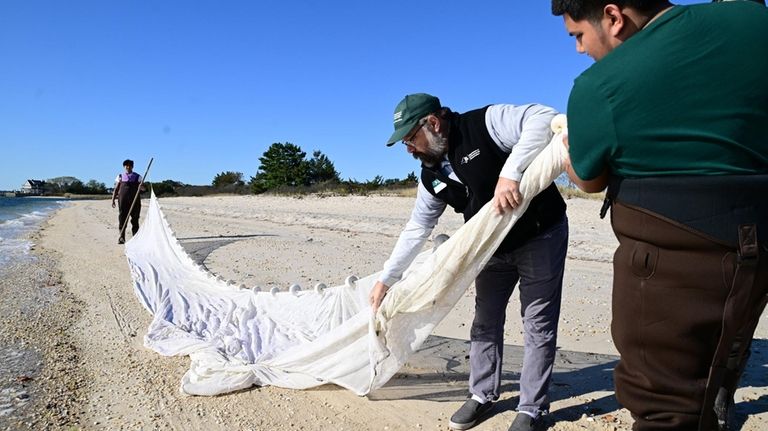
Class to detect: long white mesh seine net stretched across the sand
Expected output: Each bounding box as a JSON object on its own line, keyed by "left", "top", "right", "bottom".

{"left": 125, "top": 116, "right": 566, "bottom": 395}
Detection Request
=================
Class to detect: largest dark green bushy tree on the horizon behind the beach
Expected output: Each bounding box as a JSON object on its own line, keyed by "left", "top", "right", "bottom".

{"left": 250, "top": 142, "right": 309, "bottom": 193}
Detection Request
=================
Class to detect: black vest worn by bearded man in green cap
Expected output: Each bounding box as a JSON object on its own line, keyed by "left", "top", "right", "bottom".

{"left": 421, "top": 107, "right": 565, "bottom": 253}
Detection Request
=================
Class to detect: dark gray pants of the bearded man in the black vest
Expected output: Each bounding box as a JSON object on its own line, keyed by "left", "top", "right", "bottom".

{"left": 469, "top": 217, "right": 568, "bottom": 415}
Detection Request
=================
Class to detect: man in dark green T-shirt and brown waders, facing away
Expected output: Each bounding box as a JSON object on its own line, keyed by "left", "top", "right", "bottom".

{"left": 552, "top": 0, "right": 768, "bottom": 431}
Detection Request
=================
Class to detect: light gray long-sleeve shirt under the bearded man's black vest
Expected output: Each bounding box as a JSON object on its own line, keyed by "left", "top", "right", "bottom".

{"left": 379, "top": 104, "right": 557, "bottom": 286}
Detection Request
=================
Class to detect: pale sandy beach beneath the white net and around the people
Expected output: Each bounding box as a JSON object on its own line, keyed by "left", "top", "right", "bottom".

{"left": 0, "top": 196, "right": 768, "bottom": 431}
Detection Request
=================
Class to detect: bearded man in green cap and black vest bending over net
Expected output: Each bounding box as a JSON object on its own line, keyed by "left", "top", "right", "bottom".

{"left": 370, "top": 93, "right": 568, "bottom": 431}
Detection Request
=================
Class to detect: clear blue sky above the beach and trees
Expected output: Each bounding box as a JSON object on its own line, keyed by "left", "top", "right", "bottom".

{"left": 0, "top": 0, "right": 698, "bottom": 190}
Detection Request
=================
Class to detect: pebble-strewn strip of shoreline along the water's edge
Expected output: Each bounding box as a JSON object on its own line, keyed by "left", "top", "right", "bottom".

{"left": 0, "top": 216, "right": 86, "bottom": 429}
